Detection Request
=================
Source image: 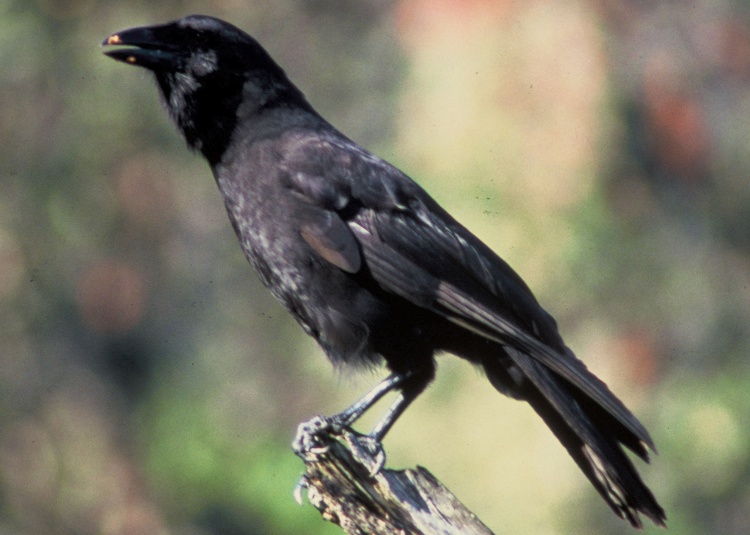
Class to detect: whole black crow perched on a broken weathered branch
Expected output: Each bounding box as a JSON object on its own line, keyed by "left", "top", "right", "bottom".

{"left": 103, "top": 15, "right": 666, "bottom": 527}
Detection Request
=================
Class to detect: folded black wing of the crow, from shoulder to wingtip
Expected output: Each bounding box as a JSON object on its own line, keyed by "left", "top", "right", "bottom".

{"left": 288, "top": 132, "right": 654, "bottom": 458}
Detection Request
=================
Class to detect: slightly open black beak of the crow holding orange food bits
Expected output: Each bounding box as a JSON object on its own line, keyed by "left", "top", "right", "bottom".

{"left": 102, "top": 26, "right": 180, "bottom": 71}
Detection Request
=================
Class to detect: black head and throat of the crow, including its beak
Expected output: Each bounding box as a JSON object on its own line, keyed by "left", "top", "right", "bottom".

{"left": 102, "top": 15, "right": 311, "bottom": 164}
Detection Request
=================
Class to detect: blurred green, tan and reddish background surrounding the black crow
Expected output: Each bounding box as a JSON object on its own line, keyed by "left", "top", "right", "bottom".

{"left": 0, "top": 0, "right": 750, "bottom": 535}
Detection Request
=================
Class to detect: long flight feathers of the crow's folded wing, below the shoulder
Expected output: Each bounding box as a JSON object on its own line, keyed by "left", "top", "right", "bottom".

{"left": 356, "top": 203, "right": 654, "bottom": 452}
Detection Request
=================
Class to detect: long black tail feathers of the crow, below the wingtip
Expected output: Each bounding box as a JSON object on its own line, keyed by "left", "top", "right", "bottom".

{"left": 483, "top": 346, "right": 666, "bottom": 528}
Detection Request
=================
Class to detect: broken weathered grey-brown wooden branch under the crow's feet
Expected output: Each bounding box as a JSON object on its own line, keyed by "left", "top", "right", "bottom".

{"left": 293, "top": 421, "right": 500, "bottom": 535}
